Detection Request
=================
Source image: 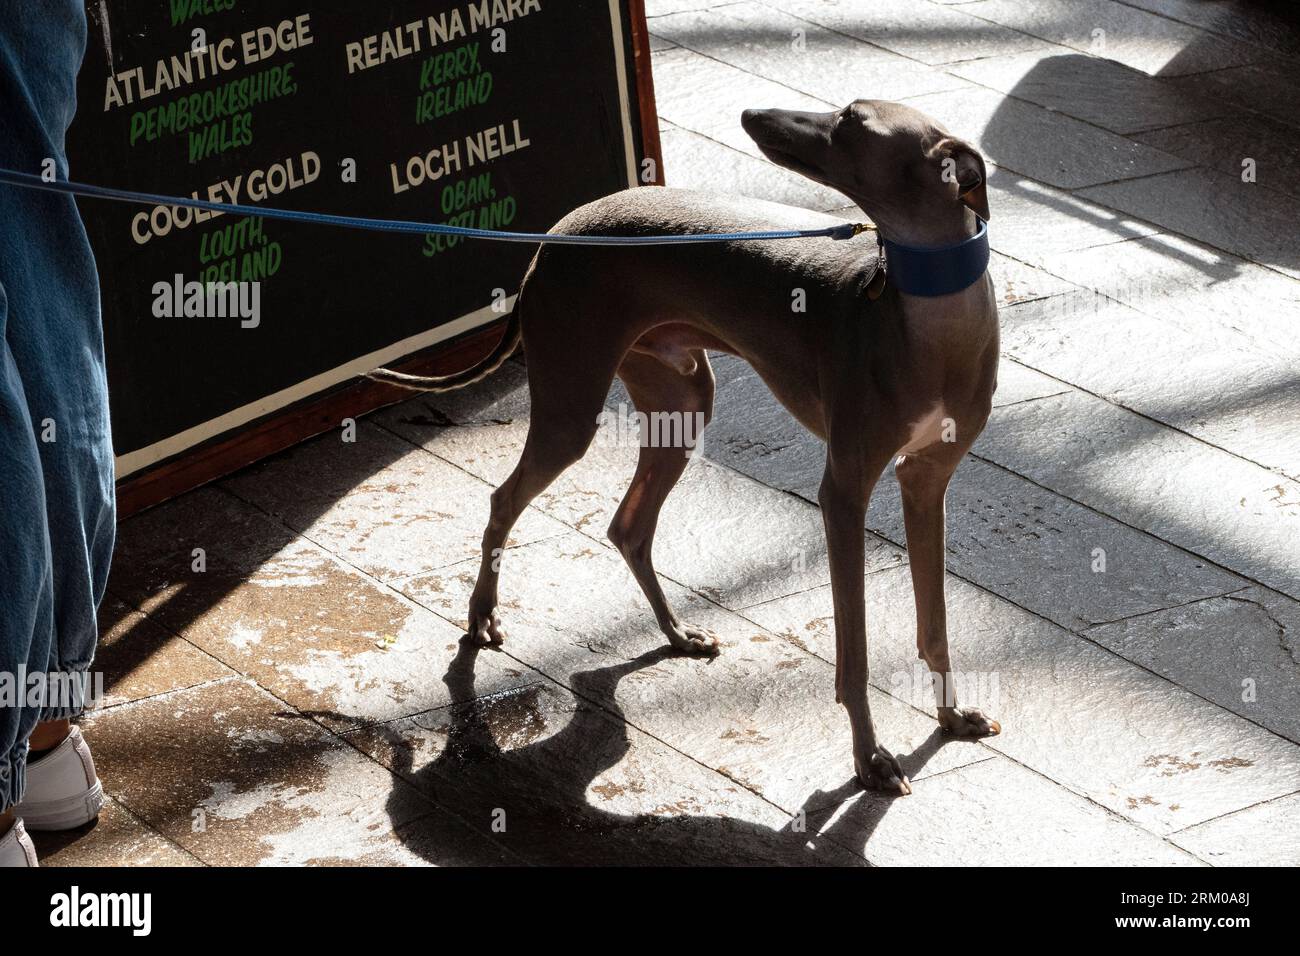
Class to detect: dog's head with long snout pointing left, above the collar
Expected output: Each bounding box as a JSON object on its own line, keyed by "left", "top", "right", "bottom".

{"left": 741, "top": 100, "right": 988, "bottom": 243}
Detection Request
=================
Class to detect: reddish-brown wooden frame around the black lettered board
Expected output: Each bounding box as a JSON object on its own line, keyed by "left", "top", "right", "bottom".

{"left": 107, "top": 0, "right": 663, "bottom": 518}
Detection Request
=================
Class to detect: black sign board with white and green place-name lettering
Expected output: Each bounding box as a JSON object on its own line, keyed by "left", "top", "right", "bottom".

{"left": 69, "top": 0, "right": 658, "bottom": 512}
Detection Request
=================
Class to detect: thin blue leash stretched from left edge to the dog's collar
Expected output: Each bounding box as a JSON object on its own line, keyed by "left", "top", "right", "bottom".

{"left": 0, "top": 166, "right": 874, "bottom": 246}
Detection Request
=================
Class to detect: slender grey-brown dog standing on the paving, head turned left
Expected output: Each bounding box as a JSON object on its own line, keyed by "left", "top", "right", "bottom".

{"left": 374, "top": 100, "right": 1001, "bottom": 793}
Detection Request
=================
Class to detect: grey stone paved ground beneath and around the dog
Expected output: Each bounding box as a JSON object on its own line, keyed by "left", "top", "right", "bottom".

{"left": 42, "top": 0, "right": 1300, "bottom": 865}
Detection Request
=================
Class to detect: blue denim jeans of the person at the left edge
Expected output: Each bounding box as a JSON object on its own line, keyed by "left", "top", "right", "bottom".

{"left": 0, "top": 0, "right": 114, "bottom": 812}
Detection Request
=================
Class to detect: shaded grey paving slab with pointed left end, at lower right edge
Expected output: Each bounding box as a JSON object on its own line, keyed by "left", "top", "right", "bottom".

{"left": 1084, "top": 588, "right": 1300, "bottom": 743}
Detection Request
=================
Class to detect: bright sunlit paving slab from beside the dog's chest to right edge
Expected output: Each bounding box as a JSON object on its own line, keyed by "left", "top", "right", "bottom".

{"left": 980, "top": 393, "right": 1300, "bottom": 597}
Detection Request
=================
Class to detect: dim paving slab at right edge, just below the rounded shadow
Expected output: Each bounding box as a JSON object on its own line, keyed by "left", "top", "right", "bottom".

{"left": 1079, "top": 168, "right": 1300, "bottom": 278}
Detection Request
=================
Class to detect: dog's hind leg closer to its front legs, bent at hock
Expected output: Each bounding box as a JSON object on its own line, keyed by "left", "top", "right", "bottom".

{"left": 608, "top": 349, "right": 718, "bottom": 654}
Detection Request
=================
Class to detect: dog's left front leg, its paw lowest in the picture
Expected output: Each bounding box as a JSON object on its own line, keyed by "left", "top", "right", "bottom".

{"left": 818, "top": 449, "right": 911, "bottom": 793}
